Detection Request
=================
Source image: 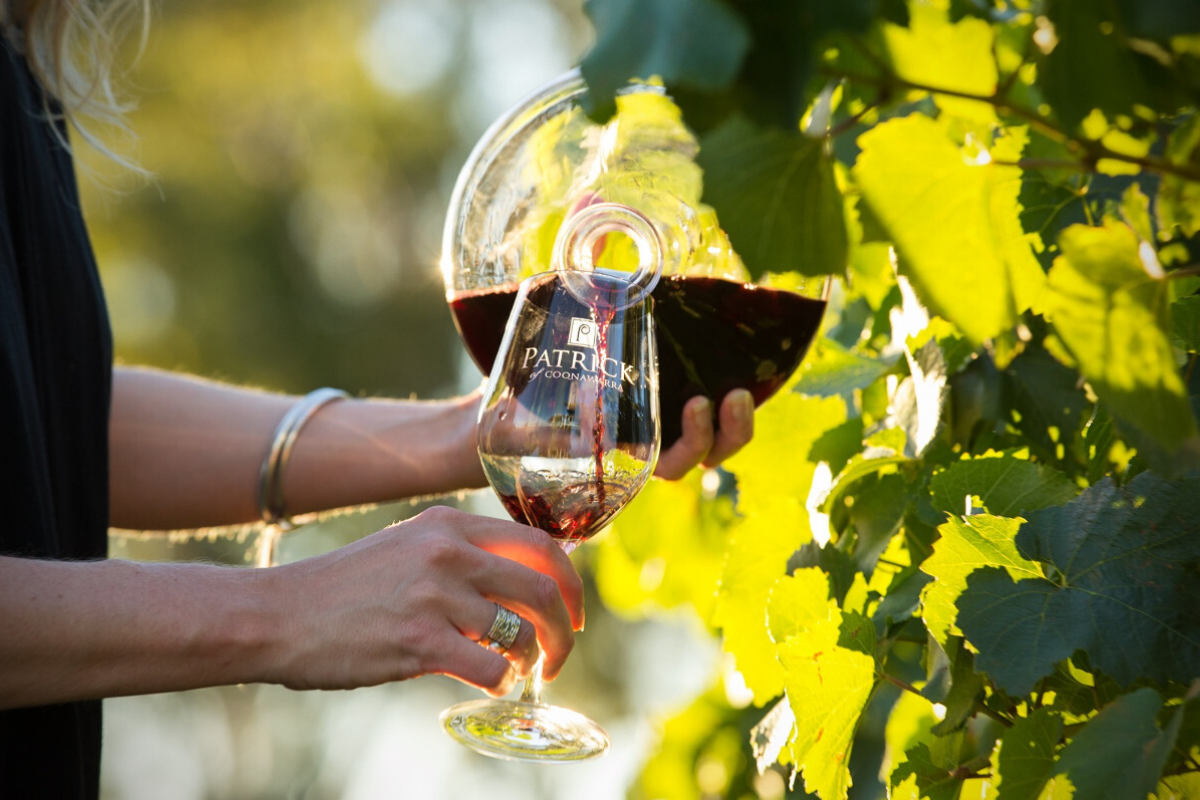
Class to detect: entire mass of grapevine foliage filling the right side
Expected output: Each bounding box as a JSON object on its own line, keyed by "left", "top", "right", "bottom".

{"left": 582, "top": 0, "right": 1200, "bottom": 800}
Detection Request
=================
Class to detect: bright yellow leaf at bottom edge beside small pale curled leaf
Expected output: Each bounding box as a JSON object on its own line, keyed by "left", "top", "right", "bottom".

{"left": 779, "top": 618, "right": 875, "bottom": 800}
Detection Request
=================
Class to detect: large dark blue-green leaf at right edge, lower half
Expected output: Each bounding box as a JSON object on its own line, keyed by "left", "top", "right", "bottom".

{"left": 960, "top": 473, "right": 1200, "bottom": 697}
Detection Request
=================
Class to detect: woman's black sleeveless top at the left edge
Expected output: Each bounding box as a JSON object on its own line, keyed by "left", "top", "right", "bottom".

{"left": 0, "top": 30, "right": 113, "bottom": 800}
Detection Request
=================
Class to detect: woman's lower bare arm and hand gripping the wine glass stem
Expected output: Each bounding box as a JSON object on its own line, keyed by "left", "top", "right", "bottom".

{"left": 0, "top": 509, "right": 583, "bottom": 708}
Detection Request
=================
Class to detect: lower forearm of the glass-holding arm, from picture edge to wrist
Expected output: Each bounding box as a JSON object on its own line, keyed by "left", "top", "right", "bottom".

{"left": 0, "top": 557, "right": 287, "bottom": 708}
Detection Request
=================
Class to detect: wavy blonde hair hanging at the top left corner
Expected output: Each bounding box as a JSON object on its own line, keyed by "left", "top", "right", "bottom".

{"left": 0, "top": 0, "right": 150, "bottom": 172}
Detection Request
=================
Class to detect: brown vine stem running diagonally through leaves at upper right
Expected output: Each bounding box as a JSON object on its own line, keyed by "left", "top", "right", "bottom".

{"left": 827, "top": 61, "right": 1200, "bottom": 182}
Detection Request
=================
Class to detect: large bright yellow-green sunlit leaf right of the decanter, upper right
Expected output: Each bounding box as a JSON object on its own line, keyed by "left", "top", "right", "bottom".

{"left": 853, "top": 114, "right": 1042, "bottom": 344}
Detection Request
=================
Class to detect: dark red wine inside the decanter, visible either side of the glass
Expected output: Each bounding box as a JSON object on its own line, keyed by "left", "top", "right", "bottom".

{"left": 449, "top": 275, "right": 826, "bottom": 447}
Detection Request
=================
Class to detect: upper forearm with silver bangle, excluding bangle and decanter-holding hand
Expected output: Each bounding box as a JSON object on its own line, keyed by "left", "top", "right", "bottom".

{"left": 110, "top": 368, "right": 482, "bottom": 529}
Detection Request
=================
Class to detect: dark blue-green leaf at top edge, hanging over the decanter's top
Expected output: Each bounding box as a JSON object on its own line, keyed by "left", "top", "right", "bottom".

{"left": 580, "top": 0, "right": 750, "bottom": 119}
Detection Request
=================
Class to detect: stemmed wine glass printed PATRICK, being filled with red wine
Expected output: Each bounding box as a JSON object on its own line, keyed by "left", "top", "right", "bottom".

{"left": 442, "top": 204, "right": 661, "bottom": 762}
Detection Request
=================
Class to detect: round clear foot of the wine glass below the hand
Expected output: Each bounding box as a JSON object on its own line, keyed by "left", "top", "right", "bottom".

{"left": 442, "top": 699, "right": 611, "bottom": 763}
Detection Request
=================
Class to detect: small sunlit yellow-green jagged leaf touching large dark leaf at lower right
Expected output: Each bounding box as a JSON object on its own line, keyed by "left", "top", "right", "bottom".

{"left": 920, "top": 515, "right": 1042, "bottom": 646}
